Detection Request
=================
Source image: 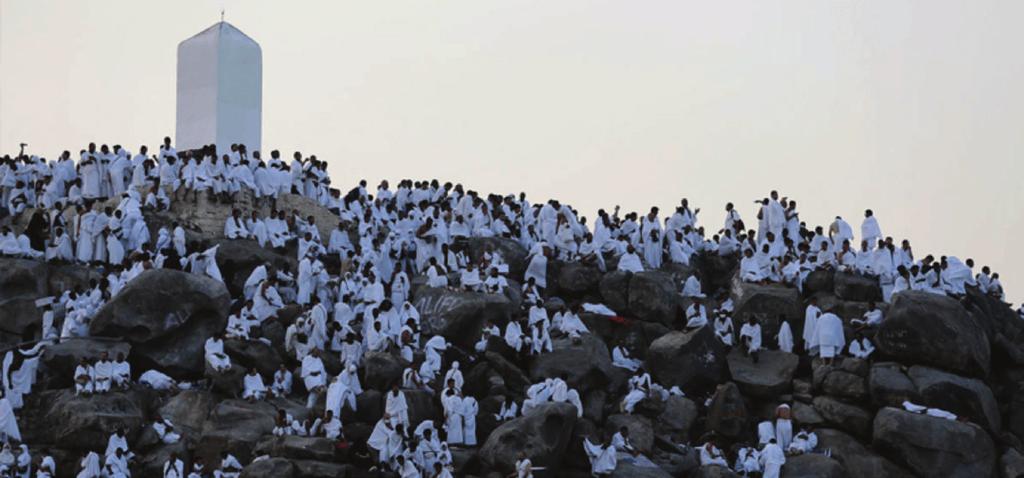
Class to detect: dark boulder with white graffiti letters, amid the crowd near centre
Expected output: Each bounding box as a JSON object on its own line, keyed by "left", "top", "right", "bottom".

{"left": 413, "top": 287, "right": 513, "bottom": 350}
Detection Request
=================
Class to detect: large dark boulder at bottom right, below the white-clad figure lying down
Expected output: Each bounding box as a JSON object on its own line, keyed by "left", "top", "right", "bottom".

{"left": 872, "top": 407, "right": 996, "bottom": 477}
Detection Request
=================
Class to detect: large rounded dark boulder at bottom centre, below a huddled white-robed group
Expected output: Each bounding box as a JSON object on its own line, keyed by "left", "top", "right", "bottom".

{"left": 479, "top": 402, "right": 577, "bottom": 474}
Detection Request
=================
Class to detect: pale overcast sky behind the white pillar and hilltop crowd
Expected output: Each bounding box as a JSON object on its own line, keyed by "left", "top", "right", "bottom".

{"left": 0, "top": 0, "right": 1024, "bottom": 301}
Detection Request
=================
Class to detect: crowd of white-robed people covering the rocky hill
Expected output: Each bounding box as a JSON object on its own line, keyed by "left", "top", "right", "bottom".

{"left": 0, "top": 138, "right": 1011, "bottom": 478}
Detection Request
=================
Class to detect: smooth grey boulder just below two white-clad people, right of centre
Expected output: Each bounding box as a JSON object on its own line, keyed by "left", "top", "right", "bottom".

{"left": 728, "top": 349, "right": 800, "bottom": 398}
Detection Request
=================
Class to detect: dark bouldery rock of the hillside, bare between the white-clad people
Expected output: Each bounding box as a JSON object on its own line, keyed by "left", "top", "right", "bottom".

{"left": 0, "top": 194, "right": 1024, "bottom": 478}
